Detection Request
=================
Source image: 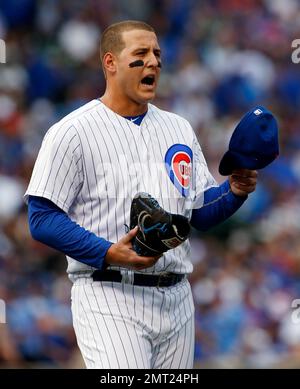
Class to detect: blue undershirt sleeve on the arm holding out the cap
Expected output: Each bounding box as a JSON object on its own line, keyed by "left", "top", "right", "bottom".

{"left": 191, "top": 180, "right": 248, "bottom": 231}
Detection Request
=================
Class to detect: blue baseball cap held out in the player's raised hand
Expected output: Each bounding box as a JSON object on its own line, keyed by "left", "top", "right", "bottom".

{"left": 219, "top": 106, "right": 279, "bottom": 176}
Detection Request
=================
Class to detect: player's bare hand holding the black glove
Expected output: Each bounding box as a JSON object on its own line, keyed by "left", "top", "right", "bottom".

{"left": 105, "top": 227, "right": 161, "bottom": 270}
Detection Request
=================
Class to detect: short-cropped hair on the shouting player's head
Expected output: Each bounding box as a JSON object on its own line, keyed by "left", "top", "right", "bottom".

{"left": 100, "top": 20, "right": 155, "bottom": 62}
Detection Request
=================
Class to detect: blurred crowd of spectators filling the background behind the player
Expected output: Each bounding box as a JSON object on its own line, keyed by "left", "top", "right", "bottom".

{"left": 0, "top": 0, "right": 300, "bottom": 368}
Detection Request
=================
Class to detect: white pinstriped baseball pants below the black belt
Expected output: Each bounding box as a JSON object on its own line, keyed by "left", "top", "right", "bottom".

{"left": 72, "top": 278, "right": 194, "bottom": 369}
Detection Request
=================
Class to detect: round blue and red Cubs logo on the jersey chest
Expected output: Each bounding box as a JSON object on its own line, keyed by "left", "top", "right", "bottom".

{"left": 165, "top": 143, "right": 193, "bottom": 197}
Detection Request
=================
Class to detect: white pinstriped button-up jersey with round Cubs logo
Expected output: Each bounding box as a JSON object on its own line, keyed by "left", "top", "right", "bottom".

{"left": 25, "top": 100, "right": 216, "bottom": 275}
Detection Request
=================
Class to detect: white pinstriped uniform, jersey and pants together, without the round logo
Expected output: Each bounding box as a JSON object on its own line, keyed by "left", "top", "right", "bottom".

{"left": 25, "top": 100, "right": 216, "bottom": 369}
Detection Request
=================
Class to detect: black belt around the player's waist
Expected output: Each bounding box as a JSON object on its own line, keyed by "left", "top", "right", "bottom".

{"left": 92, "top": 270, "right": 185, "bottom": 287}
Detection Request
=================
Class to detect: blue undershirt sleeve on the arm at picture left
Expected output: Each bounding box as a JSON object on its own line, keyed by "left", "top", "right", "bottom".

{"left": 28, "top": 196, "right": 112, "bottom": 269}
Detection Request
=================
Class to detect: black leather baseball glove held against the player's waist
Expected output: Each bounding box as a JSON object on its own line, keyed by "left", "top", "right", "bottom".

{"left": 130, "top": 192, "right": 190, "bottom": 257}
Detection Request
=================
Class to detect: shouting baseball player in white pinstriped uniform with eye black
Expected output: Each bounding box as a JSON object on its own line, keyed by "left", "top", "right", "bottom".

{"left": 25, "top": 21, "right": 257, "bottom": 369}
